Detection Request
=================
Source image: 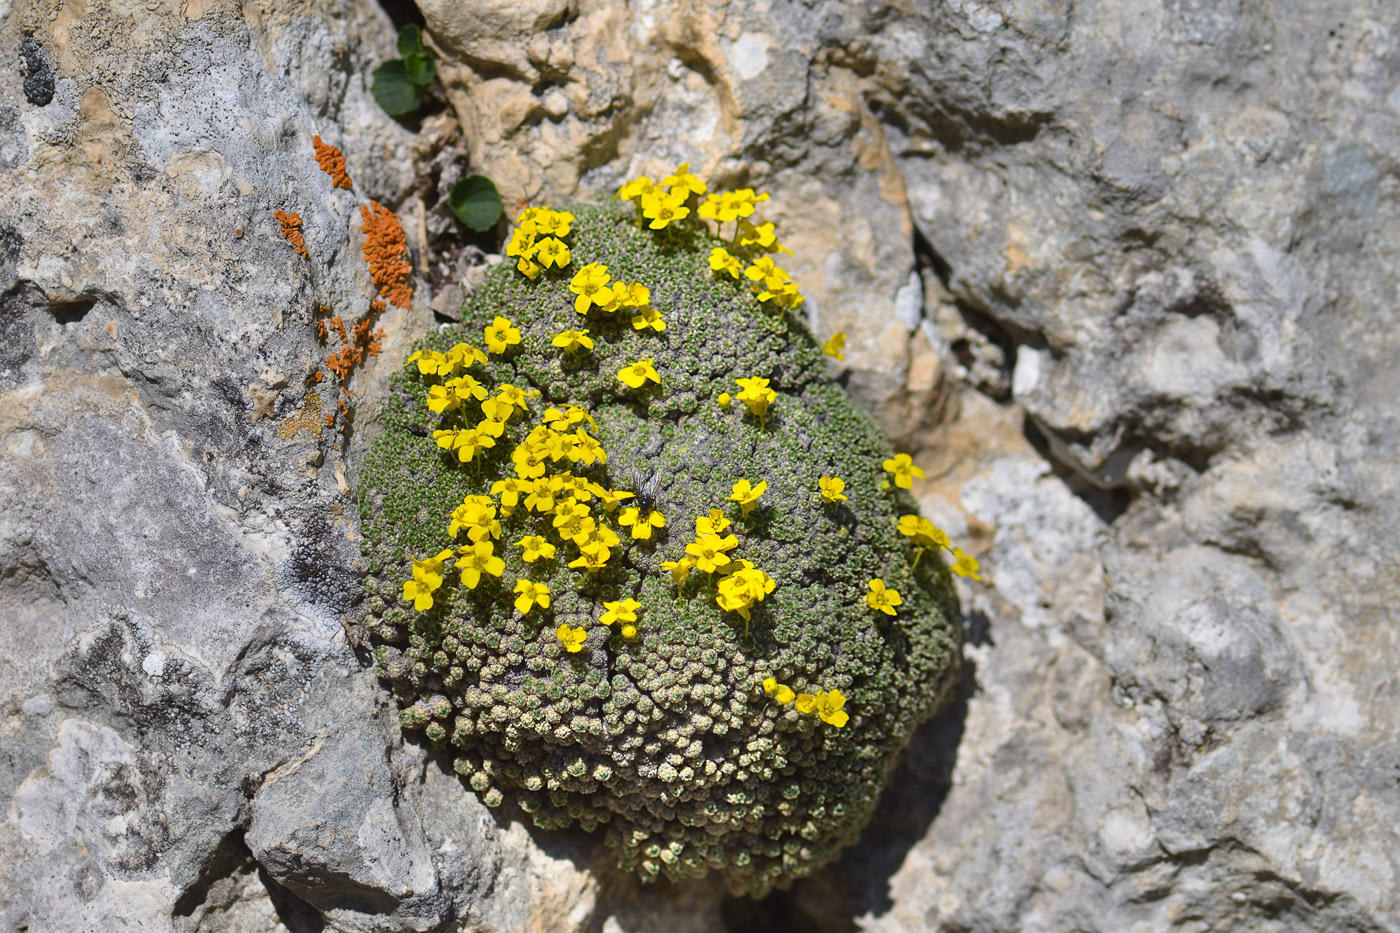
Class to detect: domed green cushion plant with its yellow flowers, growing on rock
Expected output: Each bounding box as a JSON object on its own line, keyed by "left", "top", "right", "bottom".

{"left": 360, "top": 196, "right": 974, "bottom": 895}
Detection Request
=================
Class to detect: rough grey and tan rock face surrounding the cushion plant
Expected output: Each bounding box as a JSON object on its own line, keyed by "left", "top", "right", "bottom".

{"left": 0, "top": 0, "right": 1400, "bottom": 933}
